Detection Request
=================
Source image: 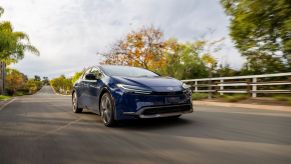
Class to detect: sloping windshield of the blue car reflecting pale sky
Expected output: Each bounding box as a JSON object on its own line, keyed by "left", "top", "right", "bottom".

{"left": 102, "top": 65, "right": 159, "bottom": 77}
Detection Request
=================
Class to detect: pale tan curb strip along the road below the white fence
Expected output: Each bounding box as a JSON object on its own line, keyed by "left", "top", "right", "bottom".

{"left": 192, "top": 101, "right": 291, "bottom": 112}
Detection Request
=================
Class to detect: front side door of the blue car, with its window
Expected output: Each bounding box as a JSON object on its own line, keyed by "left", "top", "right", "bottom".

{"left": 88, "top": 67, "right": 103, "bottom": 113}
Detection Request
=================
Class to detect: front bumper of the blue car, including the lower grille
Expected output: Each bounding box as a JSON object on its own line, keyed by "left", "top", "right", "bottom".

{"left": 113, "top": 89, "right": 193, "bottom": 120}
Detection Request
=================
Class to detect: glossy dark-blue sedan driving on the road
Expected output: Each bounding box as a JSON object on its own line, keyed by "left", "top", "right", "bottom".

{"left": 72, "top": 65, "right": 193, "bottom": 126}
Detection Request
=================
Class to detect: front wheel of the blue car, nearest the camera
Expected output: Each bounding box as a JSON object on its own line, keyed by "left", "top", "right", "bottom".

{"left": 100, "top": 93, "right": 115, "bottom": 127}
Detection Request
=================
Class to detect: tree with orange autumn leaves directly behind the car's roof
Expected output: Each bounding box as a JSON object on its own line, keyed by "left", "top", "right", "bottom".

{"left": 97, "top": 27, "right": 166, "bottom": 71}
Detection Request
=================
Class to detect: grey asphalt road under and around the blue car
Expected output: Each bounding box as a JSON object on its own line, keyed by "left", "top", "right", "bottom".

{"left": 0, "top": 87, "right": 291, "bottom": 164}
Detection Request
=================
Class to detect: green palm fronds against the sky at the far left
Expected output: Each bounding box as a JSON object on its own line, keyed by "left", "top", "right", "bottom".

{"left": 0, "top": 7, "right": 39, "bottom": 64}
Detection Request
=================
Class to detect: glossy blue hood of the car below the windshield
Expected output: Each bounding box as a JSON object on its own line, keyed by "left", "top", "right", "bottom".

{"left": 112, "top": 76, "right": 182, "bottom": 92}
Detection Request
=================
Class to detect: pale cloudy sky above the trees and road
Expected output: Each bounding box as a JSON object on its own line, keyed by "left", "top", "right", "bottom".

{"left": 0, "top": 0, "right": 244, "bottom": 78}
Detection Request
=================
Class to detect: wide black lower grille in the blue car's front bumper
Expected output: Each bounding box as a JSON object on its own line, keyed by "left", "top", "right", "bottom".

{"left": 142, "top": 105, "right": 191, "bottom": 115}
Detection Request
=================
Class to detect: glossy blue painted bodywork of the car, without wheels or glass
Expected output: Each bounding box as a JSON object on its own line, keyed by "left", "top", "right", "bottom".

{"left": 74, "top": 66, "right": 192, "bottom": 120}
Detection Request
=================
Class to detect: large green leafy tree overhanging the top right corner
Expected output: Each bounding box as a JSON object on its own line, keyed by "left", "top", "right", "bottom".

{"left": 221, "top": 0, "right": 291, "bottom": 71}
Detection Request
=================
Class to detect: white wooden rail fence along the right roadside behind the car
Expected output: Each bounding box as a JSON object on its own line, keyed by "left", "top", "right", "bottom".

{"left": 182, "top": 72, "right": 291, "bottom": 97}
